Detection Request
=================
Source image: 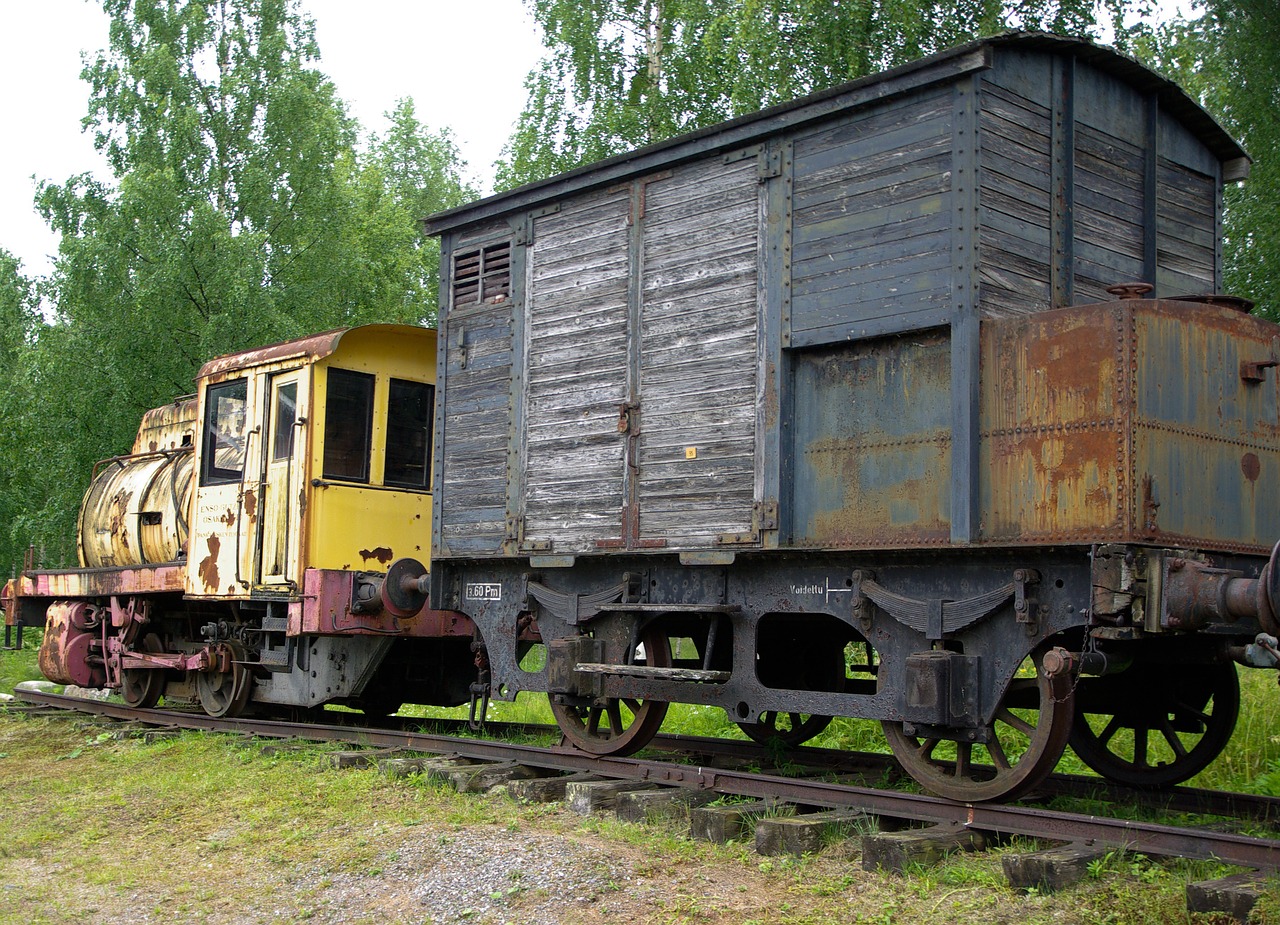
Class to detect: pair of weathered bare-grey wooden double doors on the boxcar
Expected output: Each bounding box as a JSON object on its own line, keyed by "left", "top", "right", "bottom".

{"left": 521, "top": 157, "right": 760, "bottom": 554}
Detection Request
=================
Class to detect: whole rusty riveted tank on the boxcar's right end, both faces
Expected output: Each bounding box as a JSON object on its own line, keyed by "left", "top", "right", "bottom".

{"left": 979, "top": 299, "right": 1280, "bottom": 553}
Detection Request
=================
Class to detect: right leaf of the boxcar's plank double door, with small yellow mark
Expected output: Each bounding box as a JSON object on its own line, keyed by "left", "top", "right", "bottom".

{"left": 639, "top": 156, "right": 760, "bottom": 549}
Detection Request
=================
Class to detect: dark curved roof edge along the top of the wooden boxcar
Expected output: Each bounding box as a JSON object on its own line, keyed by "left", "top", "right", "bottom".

{"left": 424, "top": 32, "right": 1249, "bottom": 234}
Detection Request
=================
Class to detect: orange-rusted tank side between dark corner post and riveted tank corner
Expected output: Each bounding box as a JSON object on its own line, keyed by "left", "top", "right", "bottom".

{"left": 979, "top": 306, "right": 1128, "bottom": 542}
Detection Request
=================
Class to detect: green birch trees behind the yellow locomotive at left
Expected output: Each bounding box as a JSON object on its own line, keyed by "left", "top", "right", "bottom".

{"left": 0, "top": 0, "right": 472, "bottom": 571}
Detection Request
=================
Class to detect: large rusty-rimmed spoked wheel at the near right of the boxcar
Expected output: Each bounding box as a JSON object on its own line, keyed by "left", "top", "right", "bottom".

{"left": 883, "top": 655, "right": 1073, "bottom": 803}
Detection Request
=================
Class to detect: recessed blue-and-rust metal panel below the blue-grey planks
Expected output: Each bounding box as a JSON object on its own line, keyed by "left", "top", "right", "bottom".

{"left": 792, "top": 331, "right": 951, "bottom": 549}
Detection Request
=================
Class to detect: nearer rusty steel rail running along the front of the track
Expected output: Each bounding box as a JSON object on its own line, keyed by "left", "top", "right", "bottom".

{"left": 15, "top": 691, "right": 1280, "bottom": 871}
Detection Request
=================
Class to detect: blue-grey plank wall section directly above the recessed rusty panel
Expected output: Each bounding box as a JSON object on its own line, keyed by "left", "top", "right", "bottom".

{"left": 791, "top": 87, "right": 952, "bottom": 345}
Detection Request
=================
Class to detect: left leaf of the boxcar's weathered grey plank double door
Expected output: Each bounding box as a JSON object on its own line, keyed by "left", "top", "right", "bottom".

{"left": 524, "top": 188, "right": 630, "bottom": 553}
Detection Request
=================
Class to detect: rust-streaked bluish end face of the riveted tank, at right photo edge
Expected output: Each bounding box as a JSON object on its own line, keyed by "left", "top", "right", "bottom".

{"left": 1129, "top": 301, "right": 1280, "bottom": 553}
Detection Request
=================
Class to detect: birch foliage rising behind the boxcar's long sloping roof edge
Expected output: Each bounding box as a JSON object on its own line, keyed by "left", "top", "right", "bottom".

{"left": 498, "top": 0, "right": 1149, "bottom": 188}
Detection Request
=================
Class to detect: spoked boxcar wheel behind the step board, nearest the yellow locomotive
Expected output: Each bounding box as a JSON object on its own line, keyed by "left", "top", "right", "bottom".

{"left": 550, "top": 629, "right": 671, "bottom": 755}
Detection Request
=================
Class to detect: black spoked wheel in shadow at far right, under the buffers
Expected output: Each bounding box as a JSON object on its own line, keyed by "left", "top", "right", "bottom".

{"left": 1071, "top": 663, "right": 1240, "bottom": 787}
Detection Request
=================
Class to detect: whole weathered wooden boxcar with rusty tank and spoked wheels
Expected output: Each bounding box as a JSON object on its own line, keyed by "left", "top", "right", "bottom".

{"left": 428, "top": 35, "right": 1280, "bottom": 800}
